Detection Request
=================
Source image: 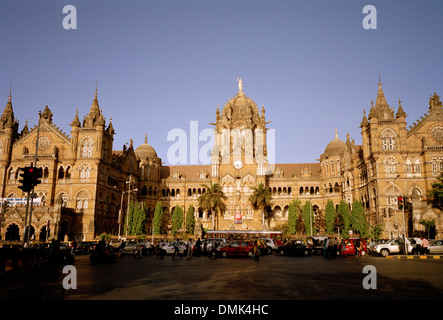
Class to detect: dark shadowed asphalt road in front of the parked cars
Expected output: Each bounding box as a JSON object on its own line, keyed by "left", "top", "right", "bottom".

{"left": 0, "top": 251, "right": 443, "bottom": 301}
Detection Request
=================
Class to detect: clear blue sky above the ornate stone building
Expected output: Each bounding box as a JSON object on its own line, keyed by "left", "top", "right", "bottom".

{"left": 0, "top": 0, "right": 443, "bottom": 163}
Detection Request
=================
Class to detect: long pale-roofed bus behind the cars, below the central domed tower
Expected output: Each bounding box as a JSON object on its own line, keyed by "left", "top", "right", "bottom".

{"left": 206, "top": 230, "right": 283, "bottom": 246}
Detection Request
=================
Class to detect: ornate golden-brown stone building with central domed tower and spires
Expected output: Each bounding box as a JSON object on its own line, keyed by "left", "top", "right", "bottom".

{"left": 0, "top": 79, "right": 443, "bottom": 240}
